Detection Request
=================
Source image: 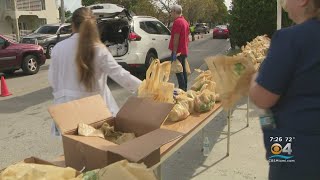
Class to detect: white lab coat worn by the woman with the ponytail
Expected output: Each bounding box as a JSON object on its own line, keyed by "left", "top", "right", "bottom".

{"left": 48, "top": 33, "right": 141, "bottom": 135}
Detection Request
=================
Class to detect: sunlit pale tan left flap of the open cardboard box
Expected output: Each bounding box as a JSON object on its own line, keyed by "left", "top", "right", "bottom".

{"left": 49, "top": 95, "right": 112, "bottom": 134}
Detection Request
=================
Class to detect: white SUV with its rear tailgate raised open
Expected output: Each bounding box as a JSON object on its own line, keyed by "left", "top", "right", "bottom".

{"left": 89, "top": 4, "right": 171, "bottom": 72}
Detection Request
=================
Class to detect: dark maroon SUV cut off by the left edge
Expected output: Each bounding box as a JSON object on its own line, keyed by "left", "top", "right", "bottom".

{"left": 0, "top": 35, "right": 46, "bottom": 74}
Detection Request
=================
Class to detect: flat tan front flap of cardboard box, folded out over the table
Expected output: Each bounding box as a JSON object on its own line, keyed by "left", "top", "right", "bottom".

{"left": 108, "top": 129, "right": 183, "bottom": 165}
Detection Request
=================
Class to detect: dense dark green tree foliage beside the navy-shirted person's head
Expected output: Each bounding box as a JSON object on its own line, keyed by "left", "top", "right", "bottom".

{"left": 229, "top": 0, "right": 291, "bottom": 47}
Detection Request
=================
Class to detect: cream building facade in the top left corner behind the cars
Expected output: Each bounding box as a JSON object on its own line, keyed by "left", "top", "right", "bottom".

{"left": 0, "top": 0, "right": 59, "bottom": 40}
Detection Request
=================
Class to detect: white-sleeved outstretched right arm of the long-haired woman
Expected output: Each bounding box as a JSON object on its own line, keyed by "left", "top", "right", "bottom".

{"left": 97, "top": 47, "right": 141, "bottom": 93}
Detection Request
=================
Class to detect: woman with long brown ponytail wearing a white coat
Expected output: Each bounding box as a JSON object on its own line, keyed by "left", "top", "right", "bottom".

{"left": 49, "top": 7, "right": 141, "bottom": 135}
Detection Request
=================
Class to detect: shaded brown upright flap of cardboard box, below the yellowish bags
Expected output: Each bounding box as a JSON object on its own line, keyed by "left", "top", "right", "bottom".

{"left": 115, "top": 97, "right": 174, "bottom": 136}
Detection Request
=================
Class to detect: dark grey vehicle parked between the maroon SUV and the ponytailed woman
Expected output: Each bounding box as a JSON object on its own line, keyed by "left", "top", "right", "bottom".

{"left": 21, "top": 23, "right": 72, "bottom": 58}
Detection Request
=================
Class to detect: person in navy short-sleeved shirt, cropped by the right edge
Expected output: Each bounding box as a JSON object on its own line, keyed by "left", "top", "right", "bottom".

{"left": 249, "top": 0, "right": 320, "bottom": 180}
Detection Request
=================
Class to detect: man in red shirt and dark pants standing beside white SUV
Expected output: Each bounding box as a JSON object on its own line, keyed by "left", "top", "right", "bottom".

{"left": 169, "top": 5, "right": 190, "bottom": 91}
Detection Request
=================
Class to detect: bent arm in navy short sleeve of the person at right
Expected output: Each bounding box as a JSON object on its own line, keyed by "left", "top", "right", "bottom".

{"left": 249, "top": 31, "right": 297, "bottom": 109}
